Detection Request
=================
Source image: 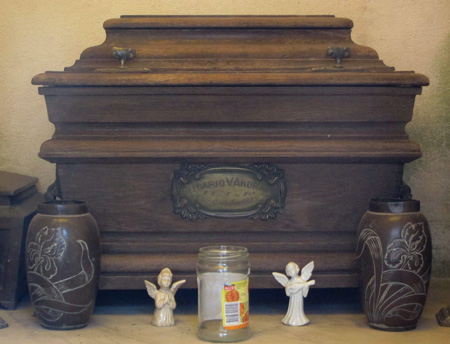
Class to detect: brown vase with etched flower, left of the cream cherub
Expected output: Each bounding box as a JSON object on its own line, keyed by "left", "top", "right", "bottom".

{"left": 26, "top": 201, "right": 101, "bottom": 330}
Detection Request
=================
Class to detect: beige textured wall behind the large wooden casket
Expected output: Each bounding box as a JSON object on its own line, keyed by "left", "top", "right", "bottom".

{"left": 0, "top": 0, "right": 450, "bottom": 276}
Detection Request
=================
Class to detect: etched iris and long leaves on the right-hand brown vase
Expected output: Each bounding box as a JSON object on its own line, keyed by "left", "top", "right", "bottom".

{"left": 356, "top": 222, "right": 430, "bottom": 326}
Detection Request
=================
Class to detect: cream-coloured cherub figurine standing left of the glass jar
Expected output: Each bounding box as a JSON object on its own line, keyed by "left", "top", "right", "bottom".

{"left": 145, "top": 268, "right": 186, "bottom": 327}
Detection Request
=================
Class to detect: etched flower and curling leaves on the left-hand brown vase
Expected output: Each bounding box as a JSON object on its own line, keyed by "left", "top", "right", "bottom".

{"left": 26, "top": 226, "right": 94, "bottom": 322}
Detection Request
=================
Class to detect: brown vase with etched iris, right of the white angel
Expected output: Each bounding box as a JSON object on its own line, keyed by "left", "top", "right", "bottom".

{"left": 356, "top": 199, "right": 431, "bottom": 331}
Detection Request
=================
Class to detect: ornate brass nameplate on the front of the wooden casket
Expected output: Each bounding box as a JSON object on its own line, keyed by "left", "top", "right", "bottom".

{"left": 172, "top": 164, "right": 286, "bottom": 220}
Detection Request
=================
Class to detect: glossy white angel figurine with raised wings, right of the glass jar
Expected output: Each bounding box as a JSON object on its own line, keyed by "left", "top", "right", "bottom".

{"left": 272, "top": 262, "right": 316, "bottom": 326}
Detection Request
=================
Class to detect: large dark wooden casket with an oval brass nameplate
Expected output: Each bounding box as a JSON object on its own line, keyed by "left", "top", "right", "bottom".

{"left": 33, "top": 16, "right": 428, "bottom": 289}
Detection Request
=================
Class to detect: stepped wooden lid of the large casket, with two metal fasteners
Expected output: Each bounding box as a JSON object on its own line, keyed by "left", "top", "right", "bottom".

{"left": 32, "top": 16, "right": 428, "bottom": 87}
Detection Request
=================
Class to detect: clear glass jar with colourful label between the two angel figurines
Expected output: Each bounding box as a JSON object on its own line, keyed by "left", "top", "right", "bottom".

{"left": 197, "top": 246, "right": 250, "bottom": 342}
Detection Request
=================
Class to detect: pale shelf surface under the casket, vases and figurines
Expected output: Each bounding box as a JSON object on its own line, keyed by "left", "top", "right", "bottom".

{"left": 0, "top": 276, "right": 450, "bottom": 344}
